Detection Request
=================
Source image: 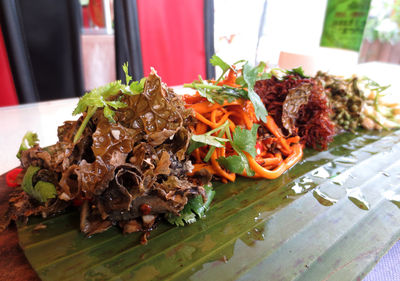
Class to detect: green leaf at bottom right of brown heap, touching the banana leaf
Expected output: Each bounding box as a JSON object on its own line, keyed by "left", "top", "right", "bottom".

{"left": 166, "top": 185, "right": 215, "bottom": 226}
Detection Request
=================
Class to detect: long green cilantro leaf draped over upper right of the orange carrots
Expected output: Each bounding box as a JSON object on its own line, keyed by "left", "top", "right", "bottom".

{"left": 243, "top": 63, "right": 268, "bottom": 122}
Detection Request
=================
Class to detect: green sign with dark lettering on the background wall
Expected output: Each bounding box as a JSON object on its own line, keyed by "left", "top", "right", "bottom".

{"left": 321, "top": 0, "right": 371, "bottom": 51}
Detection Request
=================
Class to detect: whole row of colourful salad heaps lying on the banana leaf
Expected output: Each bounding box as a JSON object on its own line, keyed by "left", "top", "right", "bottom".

{"left": 0, "top": 56, "right": 399, "bottom": 242}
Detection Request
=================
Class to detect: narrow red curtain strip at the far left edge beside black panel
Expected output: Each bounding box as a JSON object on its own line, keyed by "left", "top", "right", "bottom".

{"left": 0, "top": 29, "right": 18, "bottom": 106}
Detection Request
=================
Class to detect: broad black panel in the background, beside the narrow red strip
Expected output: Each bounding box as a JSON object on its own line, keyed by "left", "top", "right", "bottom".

{"left": 0, "top": 0, "right": 83, "bottom": 103}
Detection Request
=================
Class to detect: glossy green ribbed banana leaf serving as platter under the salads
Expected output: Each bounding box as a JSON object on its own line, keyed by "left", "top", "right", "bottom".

{"left": 14, "top": 130, "right": 400, "bottom": 281}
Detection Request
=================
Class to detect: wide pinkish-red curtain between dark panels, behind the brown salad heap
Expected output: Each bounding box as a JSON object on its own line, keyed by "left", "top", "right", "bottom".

{"left": 137, "top": 0, "right": 206, "bottom": 86}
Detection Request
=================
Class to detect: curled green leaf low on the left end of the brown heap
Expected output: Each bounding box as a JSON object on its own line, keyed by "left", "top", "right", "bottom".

{"left": 22, "top": 166, "right": 57, "bottom": 203}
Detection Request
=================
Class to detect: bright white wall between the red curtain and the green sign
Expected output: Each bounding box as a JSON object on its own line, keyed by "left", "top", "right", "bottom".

{"left": 214, "top": 0, "right": 358, "bottom": 74}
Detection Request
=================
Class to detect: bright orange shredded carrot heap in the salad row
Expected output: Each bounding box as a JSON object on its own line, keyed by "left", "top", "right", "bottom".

{"left": 184, "top": 69, "right": 303, "bottom": 183}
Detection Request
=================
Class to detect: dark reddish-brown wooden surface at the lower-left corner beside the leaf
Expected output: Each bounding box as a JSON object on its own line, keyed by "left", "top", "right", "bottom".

{"left": 0, "top": 175, "right": 40, "bottom": 281}
